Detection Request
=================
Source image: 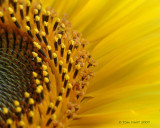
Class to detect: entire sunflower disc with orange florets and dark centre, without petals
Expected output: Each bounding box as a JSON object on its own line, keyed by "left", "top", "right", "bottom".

{"left": 0, "top": 0, "right": 94, "bottom": 128}
